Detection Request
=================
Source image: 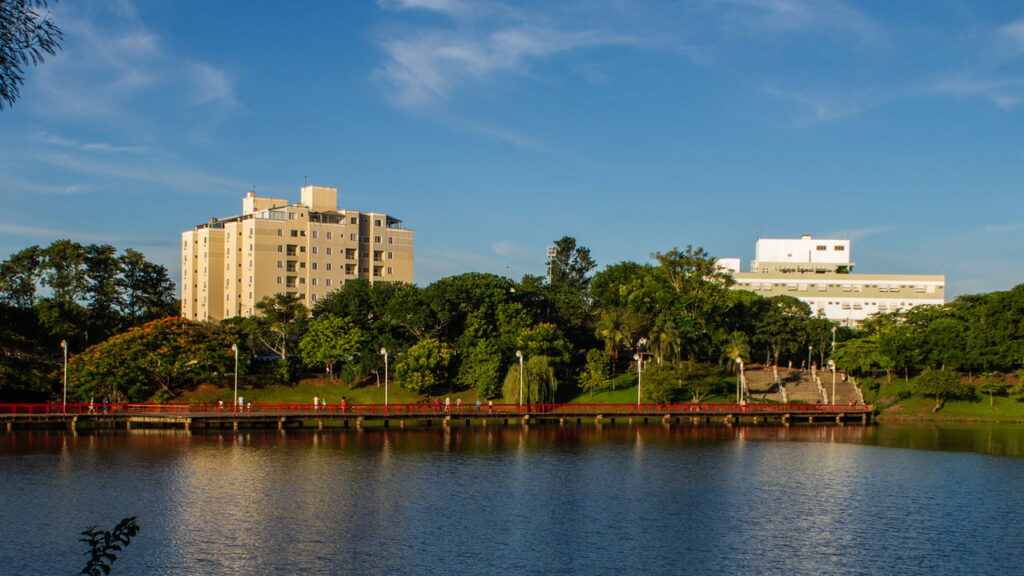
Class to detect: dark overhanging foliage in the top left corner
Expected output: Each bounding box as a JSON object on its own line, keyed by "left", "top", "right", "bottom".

{"left": 0, "top": 0, "right": 63, "bottom": 110}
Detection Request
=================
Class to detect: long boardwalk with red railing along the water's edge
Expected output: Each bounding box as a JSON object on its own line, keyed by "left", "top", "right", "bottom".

{"left": 0, "top": 403, "right": 874, "bottom": 431}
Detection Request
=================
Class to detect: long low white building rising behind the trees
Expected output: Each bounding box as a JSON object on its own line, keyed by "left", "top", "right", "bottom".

{"left": 719, "top": 236, "right": 946, "bottom": 326}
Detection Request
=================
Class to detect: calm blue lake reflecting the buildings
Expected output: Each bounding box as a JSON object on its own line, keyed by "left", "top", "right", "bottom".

{"left": 0, "top": 423, "right": 1024, "bottom": 575}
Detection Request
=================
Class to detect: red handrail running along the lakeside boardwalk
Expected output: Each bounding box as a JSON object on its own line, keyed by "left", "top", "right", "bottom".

{"left": 0, "top": 402, "right": 874, "bottom": 418}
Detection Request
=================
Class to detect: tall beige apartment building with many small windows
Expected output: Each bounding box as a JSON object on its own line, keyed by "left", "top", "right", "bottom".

{"left": 181, "top": 186, "right": 413, "bottom": 320}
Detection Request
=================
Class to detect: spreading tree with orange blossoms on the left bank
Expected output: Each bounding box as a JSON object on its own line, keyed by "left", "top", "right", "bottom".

{"left": 68, "top": 318, "right": 233, "bottom": 402}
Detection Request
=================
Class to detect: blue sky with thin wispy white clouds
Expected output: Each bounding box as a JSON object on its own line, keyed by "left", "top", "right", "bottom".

{"left": 0, "top": 0, "right": 1024, "bottom": 296}
